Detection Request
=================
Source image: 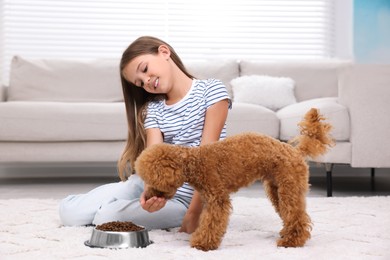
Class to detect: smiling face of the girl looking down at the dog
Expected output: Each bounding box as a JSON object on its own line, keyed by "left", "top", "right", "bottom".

{"left": 123, "top": 45, "right": 172, "bottom": 94}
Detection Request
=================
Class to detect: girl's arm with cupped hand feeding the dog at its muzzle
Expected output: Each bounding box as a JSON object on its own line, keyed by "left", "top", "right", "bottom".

{"left": 140, "top": 128, "right": 167, "bottom": 212}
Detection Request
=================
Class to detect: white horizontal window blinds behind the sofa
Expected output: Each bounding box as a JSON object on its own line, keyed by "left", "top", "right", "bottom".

{"left": 0, "top": 0, "right": 334, "bottom": 82}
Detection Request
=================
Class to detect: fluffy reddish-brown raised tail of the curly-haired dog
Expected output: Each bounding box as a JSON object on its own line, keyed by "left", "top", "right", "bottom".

{"left": 289, "top": 108, "right": 334, "bottom": 158}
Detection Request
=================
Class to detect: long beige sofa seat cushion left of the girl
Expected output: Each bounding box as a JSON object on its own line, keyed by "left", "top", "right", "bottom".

{"left": 0, "top": 101, "right": 127, "bottom": 142}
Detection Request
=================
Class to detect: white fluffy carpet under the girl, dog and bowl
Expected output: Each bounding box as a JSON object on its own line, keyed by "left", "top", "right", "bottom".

{"left": 0, "top": 197, "right": 390, "bottom": 260}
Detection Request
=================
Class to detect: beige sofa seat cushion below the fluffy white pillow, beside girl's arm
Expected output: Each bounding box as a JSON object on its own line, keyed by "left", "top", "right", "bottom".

{"left": 226, "top": 102, "right": 279, "bottom": 138}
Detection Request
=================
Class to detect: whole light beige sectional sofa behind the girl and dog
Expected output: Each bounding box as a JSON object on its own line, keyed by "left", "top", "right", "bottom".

{"left": 0, "top": 57, "right": 390, "bottom": 196}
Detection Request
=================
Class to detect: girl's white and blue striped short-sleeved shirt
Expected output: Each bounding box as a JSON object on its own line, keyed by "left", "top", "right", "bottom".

{"left": 144, "top": 79, "right": 231, "bottom": 197}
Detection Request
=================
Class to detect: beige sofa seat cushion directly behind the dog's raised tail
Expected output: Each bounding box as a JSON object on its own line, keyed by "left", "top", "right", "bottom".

{"left": 276, "top": 97, "right": 350, "bottom": 141}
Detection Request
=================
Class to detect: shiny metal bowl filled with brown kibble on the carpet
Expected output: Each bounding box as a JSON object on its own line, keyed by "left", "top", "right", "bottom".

{"left": 84, "top": 221, "right": 152, "bottom": 248}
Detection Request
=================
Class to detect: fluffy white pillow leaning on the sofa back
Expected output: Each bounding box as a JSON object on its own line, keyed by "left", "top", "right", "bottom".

{"left": 230, "top": 75, "right": 297, "bottom": 110}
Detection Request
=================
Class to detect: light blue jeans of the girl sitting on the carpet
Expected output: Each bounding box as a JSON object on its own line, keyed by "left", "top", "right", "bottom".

{"left": 59, "top": 174, "right": 191, "bottom": 229}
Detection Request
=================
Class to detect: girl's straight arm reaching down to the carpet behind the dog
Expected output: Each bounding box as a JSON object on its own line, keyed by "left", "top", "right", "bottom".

{"left": 179, "top": 99, "right": 229, "bottom": 234}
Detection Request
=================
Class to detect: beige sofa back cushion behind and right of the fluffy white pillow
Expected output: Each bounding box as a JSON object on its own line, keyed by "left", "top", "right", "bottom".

{"left": 240, "top": 60, "right": 351, "bottom": 101}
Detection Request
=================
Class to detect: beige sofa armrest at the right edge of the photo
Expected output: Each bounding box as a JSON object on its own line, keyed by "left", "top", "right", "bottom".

{"left": 339, "top": 64, "right": 390, "bottom": 168}
